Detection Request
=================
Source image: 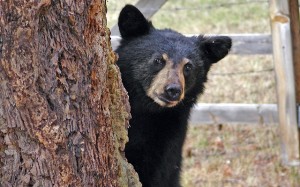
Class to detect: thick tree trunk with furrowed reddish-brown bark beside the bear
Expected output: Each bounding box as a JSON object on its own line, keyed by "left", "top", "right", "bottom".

{"left": 0, "top": 0, "right": 140, "bottom": 187}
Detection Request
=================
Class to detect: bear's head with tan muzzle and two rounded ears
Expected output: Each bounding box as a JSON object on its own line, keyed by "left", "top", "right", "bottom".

{"left": 116, "top": 5, "right": 231, "bottom": 111}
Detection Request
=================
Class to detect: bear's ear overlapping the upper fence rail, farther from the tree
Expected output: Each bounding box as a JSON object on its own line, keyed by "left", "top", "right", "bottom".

{"left": 199, "top": 36, "right": 231, "bottom": 63}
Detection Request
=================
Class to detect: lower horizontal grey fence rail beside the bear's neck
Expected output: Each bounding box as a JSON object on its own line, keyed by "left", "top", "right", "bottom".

{"left": 190, "top": 103, "right": 278, "bottom": 125}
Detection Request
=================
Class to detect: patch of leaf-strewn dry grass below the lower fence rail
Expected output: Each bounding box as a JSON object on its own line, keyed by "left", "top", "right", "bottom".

{"left": 182, "top": 125, "right": 300, "bottom": 187}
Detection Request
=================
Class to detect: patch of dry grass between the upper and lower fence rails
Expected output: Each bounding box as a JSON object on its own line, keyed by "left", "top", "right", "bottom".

{"left": 199, "top": 55, "right": 276, "bottom": 103}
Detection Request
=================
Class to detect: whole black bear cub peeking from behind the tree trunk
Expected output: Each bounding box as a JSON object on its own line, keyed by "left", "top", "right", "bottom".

{"left": 116, "top": 5, "right": 231, "bottom": 187}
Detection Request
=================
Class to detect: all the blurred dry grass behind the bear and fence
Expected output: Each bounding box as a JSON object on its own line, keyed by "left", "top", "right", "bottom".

{"left": 107, "top": 0, "right": 300, "bottom": 187}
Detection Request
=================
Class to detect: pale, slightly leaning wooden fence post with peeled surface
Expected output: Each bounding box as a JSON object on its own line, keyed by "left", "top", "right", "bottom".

{"left": 269, "top": 0, "right": 300, "bottom": 165}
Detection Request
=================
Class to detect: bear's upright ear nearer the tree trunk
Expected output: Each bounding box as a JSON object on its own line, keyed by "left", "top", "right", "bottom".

{"left": 118, "top": 5, "right": 151, "bottom": 38}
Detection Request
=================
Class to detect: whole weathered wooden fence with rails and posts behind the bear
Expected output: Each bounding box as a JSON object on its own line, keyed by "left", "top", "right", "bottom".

{"left": 111, "top": 0, "right": 300, "bottom": 165}
